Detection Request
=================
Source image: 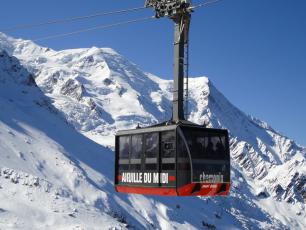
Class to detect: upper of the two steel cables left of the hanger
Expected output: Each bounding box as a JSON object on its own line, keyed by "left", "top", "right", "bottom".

{"left": 1, "top": 7, "right": 146, "bottom": 32}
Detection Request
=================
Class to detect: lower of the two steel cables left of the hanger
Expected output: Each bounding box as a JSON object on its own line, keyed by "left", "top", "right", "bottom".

{"left": 32, "top": 16, "right": 155, "bottom": 41}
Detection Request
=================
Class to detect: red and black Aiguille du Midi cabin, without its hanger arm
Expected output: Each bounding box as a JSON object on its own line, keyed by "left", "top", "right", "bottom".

{"left": 115, "top": 122, "right": 230, "bottom": 196}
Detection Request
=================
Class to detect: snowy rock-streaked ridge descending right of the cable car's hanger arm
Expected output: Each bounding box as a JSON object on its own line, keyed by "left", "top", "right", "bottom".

{"left": 185, "top": 78, "right": 306, "bottom": 203}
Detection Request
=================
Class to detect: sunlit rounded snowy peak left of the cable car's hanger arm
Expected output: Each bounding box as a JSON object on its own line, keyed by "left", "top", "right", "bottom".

{"left": 0, "top": 39, "right": 171, "bottom": 141}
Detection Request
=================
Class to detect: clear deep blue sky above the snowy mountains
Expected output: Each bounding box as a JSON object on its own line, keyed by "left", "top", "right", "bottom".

{"left": 0, "top": 0, "right": 306, "bottom": 146}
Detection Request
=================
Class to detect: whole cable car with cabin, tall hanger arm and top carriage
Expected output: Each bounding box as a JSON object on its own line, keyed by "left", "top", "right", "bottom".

{"left": 114, "top": 0, "right": 230, "bottom": 196}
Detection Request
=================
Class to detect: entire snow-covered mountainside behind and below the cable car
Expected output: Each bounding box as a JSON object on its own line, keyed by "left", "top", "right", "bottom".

{"left": 0, "top": 33, "right": 306, "bottom": 230}
